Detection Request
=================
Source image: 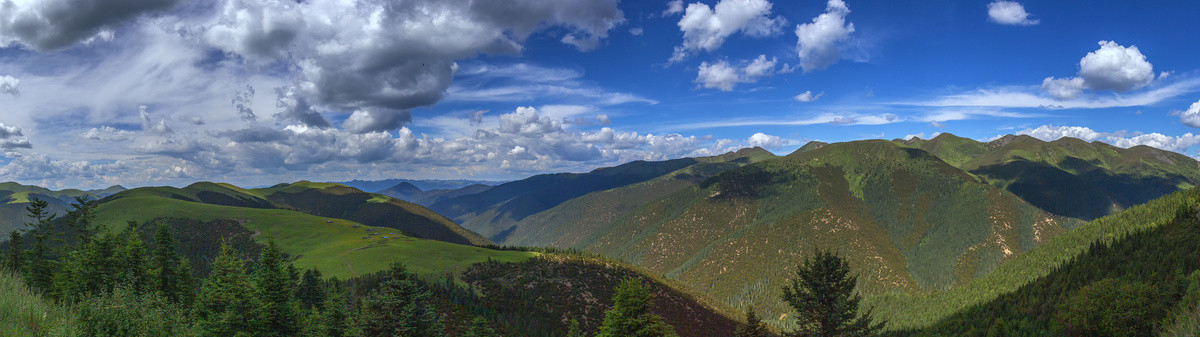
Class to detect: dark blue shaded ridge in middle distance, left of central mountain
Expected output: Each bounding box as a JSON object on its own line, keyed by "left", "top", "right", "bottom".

{"left": 430, "top": 148, "right": 773, "bottom": 242}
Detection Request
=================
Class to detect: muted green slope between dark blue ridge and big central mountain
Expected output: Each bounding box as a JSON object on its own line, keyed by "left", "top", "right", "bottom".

{"left": 499, "top": 149, "right": 776, "bottom": 248}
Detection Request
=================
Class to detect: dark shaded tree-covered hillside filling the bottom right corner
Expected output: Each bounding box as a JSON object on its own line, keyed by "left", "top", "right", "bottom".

{"left": 910, "top": 203, "right": 1200, "bottom": 336}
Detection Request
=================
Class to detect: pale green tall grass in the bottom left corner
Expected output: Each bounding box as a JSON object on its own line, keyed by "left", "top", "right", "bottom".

{"left": 0, "top": 271, "right": 78, "bottom": 337}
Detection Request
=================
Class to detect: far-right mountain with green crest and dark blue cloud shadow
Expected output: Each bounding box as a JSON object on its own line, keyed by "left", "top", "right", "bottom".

{"left": 896, "top": 133, "right": 1200, "bottom": 219}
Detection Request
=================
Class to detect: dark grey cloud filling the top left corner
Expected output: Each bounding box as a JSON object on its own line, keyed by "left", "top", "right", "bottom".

{"left": 0, "top": 0, "right": 180, "bottom": 52}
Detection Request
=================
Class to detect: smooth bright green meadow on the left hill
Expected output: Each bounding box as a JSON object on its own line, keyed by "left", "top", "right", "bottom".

{"left": 96, "top": 194, "right": 534, "bottom": 278}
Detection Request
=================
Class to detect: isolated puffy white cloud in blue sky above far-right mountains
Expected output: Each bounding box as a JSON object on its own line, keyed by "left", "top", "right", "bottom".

{"left": 1042, "top": 41, "right": 1154, "bottom": 101}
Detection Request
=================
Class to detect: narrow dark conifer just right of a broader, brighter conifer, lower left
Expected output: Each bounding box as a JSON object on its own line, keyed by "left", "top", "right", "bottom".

{"left": 254, "top": 239, "right": 301, "bottom": 336}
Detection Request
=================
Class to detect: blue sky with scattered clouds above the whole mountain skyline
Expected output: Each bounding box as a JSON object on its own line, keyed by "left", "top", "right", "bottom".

{"left": 0, "top": 0, "right": 1200, "bottom": 188}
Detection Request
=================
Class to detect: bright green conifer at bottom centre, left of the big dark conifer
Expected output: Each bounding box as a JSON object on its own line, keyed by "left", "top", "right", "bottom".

{"left": 596, "top": 278, "right": 678, "bottom": 337}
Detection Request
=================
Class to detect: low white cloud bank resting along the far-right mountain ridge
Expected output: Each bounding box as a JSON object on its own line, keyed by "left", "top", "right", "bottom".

{"left": 1012, "top": 125, "right": 1200, "bottom": 152}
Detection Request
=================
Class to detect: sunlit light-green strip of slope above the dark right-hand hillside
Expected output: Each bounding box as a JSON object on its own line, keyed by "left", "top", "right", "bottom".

{"left": 868, "top": 184, "right": 1200, "bottom": 329}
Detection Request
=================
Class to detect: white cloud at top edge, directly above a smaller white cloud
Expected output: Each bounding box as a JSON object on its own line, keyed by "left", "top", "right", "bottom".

{"left": 667, "top": 0, "right": 785, "bottom": 62}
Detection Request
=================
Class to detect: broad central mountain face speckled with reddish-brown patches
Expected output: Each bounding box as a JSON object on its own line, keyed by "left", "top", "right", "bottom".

{"left": 549, "top": 142, "right": 1063, "bottom": 321}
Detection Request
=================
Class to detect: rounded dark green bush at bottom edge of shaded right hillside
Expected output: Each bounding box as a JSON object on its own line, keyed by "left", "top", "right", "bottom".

{"left": 1054, "top": 278, "right": 1166, "bottom": 336}
